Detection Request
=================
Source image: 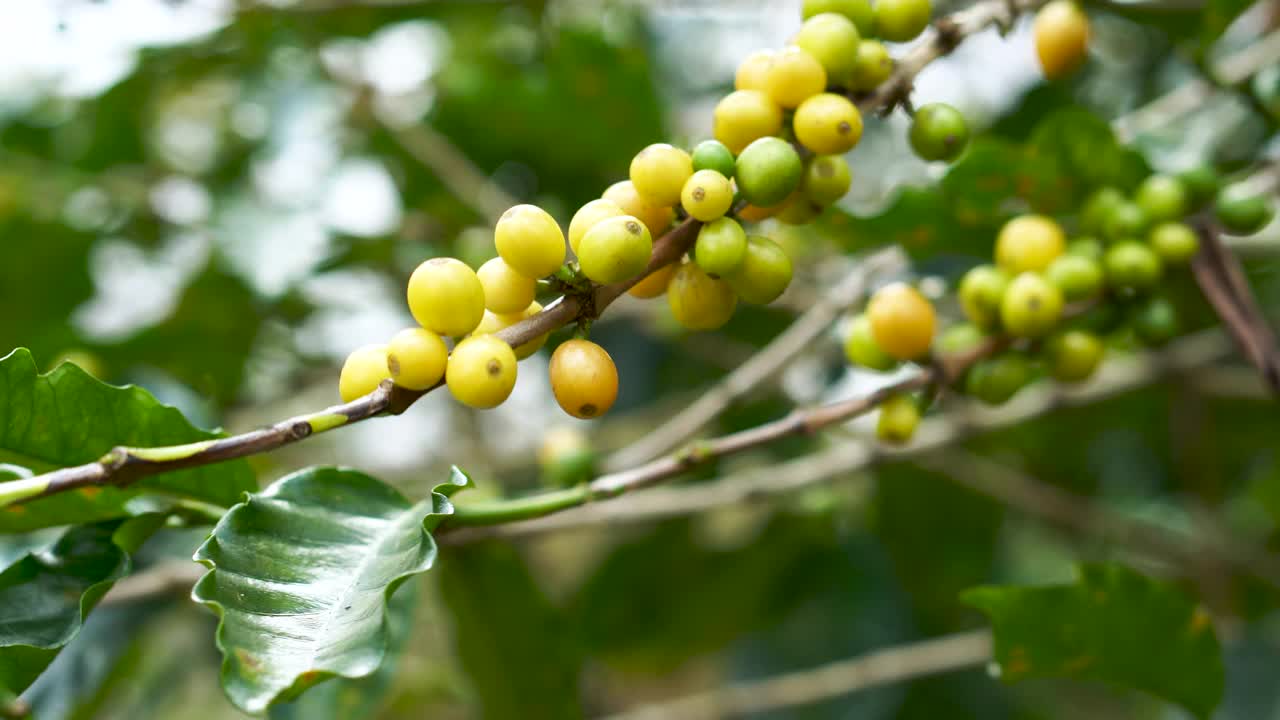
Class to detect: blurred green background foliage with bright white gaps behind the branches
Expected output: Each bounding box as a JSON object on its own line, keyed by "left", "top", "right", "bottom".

{"left": 0, "top": 0, "right": 1280, "bottom": 720}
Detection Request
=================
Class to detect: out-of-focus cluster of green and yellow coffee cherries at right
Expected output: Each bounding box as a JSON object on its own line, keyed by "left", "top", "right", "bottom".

{"left": 845, "top": 169, "right": 1271, "bottom": 442}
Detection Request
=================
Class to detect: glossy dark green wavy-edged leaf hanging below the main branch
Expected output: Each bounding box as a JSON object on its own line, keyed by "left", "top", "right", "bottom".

{"left": 192, "top": 468, "right": 470, "bottom": 712}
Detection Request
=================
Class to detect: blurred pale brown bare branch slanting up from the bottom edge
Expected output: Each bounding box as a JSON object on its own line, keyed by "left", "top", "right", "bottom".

{"left": 607, "top": 630, "right": 992, "bottom": 720}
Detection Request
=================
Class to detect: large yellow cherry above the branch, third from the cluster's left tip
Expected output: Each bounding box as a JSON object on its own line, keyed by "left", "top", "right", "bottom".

{"left": 408, "top": 258, "right": 484, "bottom": 337}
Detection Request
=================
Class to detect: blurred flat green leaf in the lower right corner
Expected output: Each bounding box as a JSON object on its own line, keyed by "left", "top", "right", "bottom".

{"left": 963, "top": 565, "right": 1225, "bottom": 717}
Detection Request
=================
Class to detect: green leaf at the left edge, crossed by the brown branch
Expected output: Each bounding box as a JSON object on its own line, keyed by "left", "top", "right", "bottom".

{"left": 0, "top": 348, "right": 256, "bottom": 533}
